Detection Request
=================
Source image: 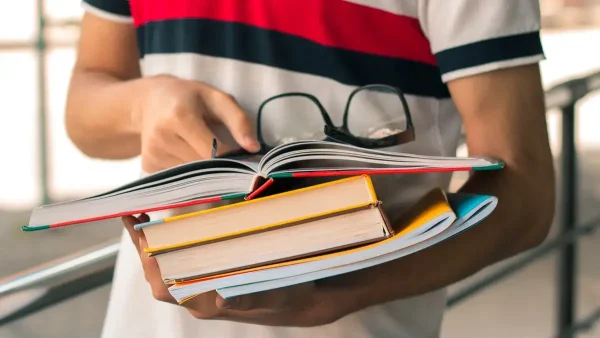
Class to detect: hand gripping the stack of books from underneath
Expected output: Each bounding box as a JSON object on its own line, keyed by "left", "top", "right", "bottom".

{"left": 123, "top": 214, "right": 352, "bottom": 327}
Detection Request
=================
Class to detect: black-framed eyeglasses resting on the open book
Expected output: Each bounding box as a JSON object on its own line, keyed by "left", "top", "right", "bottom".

{"left": 222, "top": 84, "right": 415, "bottom": 157}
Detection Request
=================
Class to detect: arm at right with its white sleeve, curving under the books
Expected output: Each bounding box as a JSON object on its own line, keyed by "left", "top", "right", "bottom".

{"left": 316, "top": 0, "right": 555, "bottom": 312}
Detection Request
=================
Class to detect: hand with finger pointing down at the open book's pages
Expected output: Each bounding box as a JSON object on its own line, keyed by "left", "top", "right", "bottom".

{"left": 131, "top": 76, "right": 260, "bottom": 173}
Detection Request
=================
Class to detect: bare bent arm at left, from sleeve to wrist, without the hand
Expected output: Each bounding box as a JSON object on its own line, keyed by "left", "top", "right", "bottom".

{"left": 65, "top": 13, "right": 143, "bottom": 159}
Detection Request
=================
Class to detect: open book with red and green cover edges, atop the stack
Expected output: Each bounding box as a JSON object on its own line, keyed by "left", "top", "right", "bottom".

{"left": 23, "top": 141, "right": 503, "bottom": 231}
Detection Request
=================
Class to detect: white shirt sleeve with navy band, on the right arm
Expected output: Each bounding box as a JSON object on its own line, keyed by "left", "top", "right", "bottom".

{"left": 418, "top": 0, "right": 544, "bottom": 82}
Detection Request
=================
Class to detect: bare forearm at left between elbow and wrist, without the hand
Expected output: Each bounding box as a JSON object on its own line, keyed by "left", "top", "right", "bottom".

{"left": 65, "top": 69, "right": 143, "bottom": 159}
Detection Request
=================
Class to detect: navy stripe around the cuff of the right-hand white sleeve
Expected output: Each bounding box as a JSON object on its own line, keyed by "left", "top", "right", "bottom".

{"left": 435, "top": 32, "right": 544, "bottom": 74}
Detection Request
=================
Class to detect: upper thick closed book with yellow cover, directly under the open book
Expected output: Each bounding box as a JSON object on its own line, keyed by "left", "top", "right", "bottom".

{"left": 135, "top": 175, "right": 381, "bottom": 255}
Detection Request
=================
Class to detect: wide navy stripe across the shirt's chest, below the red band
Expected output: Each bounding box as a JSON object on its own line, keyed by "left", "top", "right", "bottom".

{"left": 137, "top": 19, "right": 450, "bottom": 98}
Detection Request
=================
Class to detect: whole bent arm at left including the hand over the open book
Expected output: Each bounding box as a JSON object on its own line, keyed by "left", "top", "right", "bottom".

{"left": 65, "top": 0, "right": 259, "bottom": 169}
